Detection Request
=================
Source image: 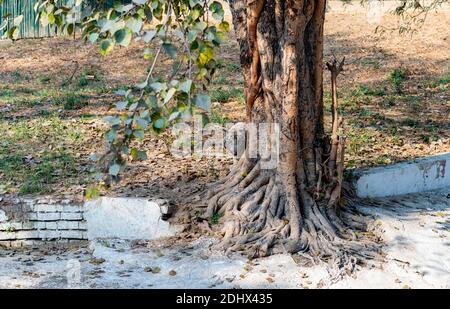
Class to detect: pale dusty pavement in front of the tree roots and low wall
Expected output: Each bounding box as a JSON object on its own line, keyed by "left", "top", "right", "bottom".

{"left": 0, "top": 188, "right": 450, "bottom": 289}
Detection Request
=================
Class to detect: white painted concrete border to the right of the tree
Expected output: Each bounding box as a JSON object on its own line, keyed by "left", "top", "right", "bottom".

{"left": 351, "top": 152, "right": 450, "bottom": 198}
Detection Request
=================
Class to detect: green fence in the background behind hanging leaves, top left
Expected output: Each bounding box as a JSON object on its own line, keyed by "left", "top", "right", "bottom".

{"left": 0, "top": 0, "right": 130, "bottom": 39}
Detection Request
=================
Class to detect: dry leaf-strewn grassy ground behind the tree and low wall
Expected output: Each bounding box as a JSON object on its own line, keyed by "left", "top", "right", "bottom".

{"left": 0, "top": 6, "right": 450, "bottom": 207}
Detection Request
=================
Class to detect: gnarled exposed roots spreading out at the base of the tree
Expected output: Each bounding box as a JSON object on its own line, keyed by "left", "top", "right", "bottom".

{"left": 205, "top": 156, "right": 377, "bottom": 280}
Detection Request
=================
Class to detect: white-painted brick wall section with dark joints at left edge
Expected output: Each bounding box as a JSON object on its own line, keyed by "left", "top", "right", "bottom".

{"left": 0, "top": 199, "right": 87, "bottom": 247}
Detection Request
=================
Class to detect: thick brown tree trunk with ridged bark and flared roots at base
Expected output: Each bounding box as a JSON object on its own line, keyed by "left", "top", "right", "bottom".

{"left": 206, "top": 0, "right": 368, "bottom": 256}
